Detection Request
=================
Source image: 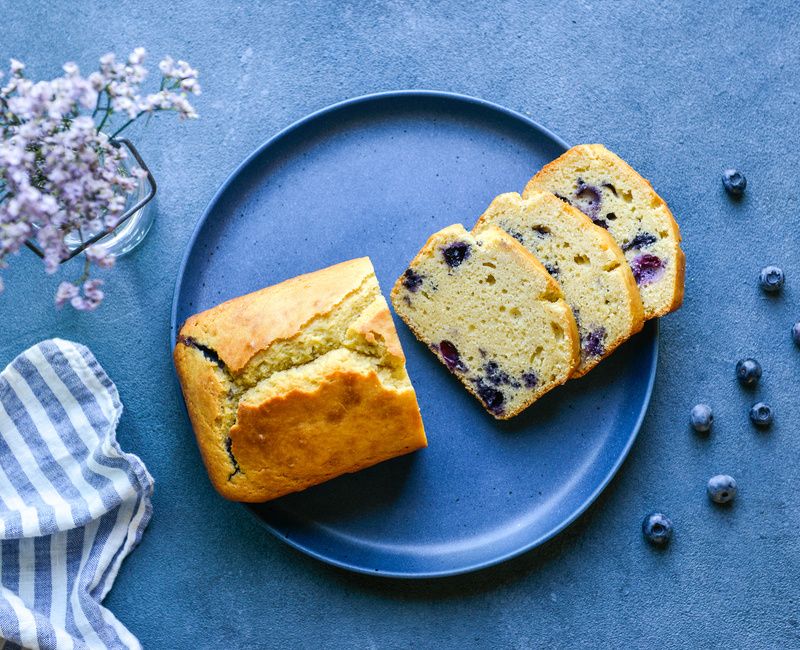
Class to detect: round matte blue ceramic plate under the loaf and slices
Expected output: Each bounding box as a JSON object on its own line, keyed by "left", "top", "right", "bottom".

{"left": 172, "top": 91, "right": 657, "bottom": 577}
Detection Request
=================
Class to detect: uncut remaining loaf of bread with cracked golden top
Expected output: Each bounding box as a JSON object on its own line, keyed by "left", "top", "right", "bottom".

{"left": 174, "top": 257, "right": 426, "bottom": 501}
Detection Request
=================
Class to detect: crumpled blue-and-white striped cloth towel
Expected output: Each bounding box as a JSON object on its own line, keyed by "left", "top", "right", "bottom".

{"left": 0, "top": 339, "right": 153, "bottom": 650}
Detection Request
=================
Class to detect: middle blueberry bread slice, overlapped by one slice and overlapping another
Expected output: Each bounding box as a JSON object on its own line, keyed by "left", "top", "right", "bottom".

{"left": 472, "top": 190, "right": 644, "bottom": 377}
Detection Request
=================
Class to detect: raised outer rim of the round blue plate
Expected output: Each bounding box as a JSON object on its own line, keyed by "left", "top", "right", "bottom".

{"left": 169, "top": 89, "right": 659, "bottom": 579}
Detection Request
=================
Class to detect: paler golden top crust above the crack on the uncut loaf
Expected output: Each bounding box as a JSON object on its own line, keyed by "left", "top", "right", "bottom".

{"left": 181, "top": 257, "right": 373, "bottom": 373}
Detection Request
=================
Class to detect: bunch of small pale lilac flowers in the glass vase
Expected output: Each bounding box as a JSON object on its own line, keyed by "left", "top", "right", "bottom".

{"left": 0, "top": 48, "right": 200, "bottom": 310}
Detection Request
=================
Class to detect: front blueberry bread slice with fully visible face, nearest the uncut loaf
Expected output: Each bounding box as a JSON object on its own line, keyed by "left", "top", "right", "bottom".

{"left": 391, "top": 225, "right": 580, "bottom": 419}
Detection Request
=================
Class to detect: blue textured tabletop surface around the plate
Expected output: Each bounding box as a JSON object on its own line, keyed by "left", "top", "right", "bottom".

{"left": 0, "top": 0, "right": 800, "bottom": 648}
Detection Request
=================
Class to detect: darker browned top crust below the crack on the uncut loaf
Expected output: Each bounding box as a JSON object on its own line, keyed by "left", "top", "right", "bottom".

{"left": 231, "top": 371, "right": 427, "bottom": 501}
